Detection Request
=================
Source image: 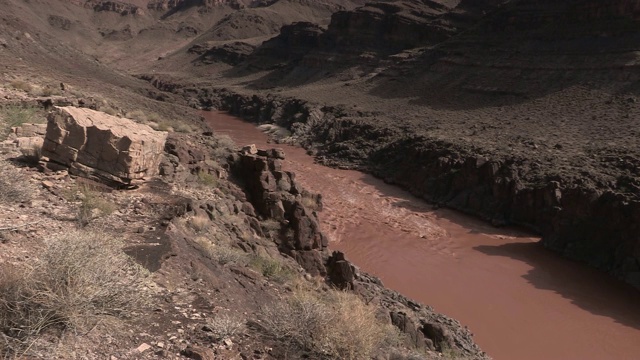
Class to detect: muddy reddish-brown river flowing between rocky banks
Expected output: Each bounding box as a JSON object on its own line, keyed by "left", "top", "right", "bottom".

{"left": 205, "top": 112, "right": 640, "bottom": 360}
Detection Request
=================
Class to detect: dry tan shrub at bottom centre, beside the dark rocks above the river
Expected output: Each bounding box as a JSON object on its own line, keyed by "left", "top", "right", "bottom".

{"left": 261, "top": 290, "right": 397, "bottom": 359}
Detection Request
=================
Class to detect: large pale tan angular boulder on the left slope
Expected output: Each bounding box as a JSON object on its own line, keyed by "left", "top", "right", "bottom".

{"left": 42, "top": 106, "right": 167, "bottom": 186}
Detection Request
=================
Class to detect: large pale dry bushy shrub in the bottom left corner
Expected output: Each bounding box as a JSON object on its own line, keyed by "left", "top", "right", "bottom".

{"left": 0, "top": 231, "right": 148, "bottom": 356}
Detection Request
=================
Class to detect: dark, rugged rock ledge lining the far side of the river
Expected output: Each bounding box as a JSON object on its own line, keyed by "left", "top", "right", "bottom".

{"left": 141, "top": 77, "right": 640, "bottom": 288}
